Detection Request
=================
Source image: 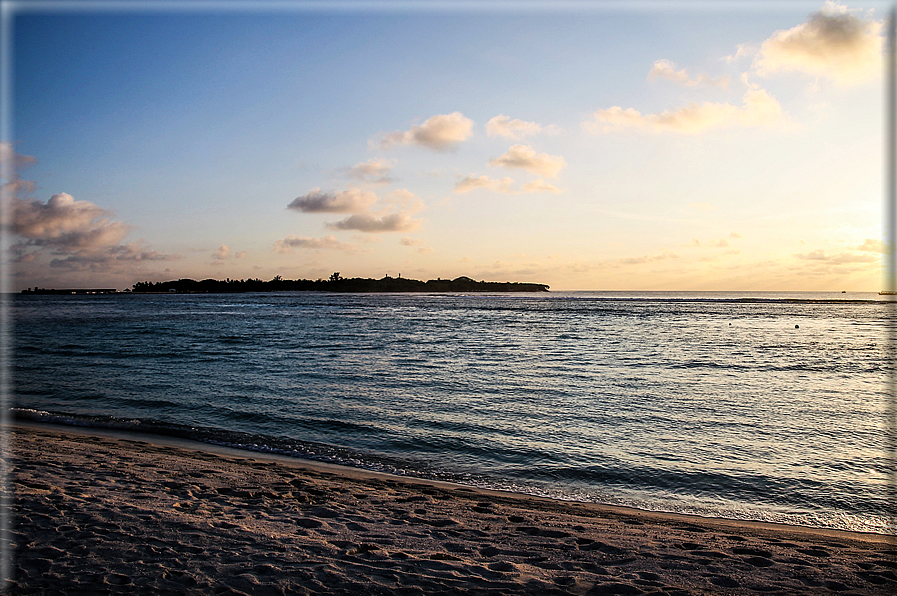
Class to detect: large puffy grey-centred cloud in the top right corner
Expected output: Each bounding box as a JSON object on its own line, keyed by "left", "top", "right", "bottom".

{"left": 753, "top": 2, "right": 884, "bottom": 85}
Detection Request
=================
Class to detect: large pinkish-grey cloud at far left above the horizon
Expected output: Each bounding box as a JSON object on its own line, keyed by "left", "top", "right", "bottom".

{"left": 11, "top": 192, "right": 134, "bottom": 251}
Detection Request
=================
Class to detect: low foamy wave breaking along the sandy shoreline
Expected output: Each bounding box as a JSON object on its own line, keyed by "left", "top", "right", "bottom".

{"left": 8, "top": 408, "right": 897, "bottom": 534}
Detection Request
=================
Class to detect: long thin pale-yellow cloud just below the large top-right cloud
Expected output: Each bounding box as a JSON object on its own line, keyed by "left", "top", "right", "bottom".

{"left": 582, "top": 86, "right": 785, "bottom": 134}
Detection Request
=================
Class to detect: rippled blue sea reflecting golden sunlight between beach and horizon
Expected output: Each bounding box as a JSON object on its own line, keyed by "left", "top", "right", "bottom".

{"left": 12, "top": 292, "right": 895, "bottom": 534}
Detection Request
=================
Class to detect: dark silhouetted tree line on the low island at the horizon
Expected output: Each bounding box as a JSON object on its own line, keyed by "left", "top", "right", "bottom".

{"left": 131, "top": 272, "right": 548, "bottom": 294}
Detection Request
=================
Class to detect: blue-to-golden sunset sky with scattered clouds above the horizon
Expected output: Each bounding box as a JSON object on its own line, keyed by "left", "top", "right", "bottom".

{"left": 0, "top": 0, "right": 890, "bottom": 291}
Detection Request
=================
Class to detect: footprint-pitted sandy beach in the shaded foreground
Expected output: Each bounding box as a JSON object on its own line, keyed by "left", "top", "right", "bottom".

{"left": 10, "top": 425, "right": 897, "bottom": 595}
